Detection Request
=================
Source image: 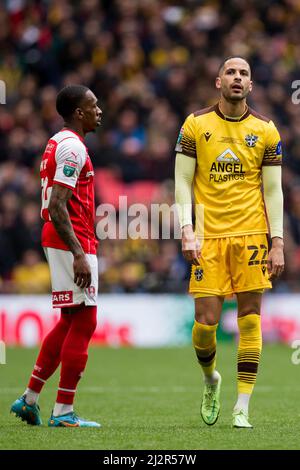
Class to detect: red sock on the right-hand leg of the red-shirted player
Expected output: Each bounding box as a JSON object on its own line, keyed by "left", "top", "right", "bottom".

{"left": 56, "top": 305, "right": 97, "bottom": 405}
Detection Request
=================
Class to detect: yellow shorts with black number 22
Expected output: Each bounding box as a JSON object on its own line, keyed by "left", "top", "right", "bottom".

{"left": 189, "top": 234, "right": 272, "bottom": 297}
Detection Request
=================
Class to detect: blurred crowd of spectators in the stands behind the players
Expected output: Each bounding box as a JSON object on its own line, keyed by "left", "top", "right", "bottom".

{"left": 0, "top": 0, "right": 300, "bottom": 293}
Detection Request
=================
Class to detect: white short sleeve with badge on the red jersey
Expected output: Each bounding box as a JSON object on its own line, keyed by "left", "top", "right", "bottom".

{"left": 53, "top": 138, "right": 87, "bottom": 189}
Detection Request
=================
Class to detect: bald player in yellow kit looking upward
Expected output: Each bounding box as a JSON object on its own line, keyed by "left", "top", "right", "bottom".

{"left": 175, "top": 57, "right": 284, "bottom": 428}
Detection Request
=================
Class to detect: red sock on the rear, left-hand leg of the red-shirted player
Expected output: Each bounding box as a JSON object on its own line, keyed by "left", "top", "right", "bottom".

{"left": 28, "top": 309, "right": 72, "bottom": 393}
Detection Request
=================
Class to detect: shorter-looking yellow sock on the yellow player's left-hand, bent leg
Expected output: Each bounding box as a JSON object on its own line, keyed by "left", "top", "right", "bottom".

{"left": 192, "top": 321, "right": 218, "bottom": 376}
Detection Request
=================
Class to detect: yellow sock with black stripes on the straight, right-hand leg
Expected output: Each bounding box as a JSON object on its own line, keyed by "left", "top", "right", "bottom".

{"left": 238, "top": 313, "right": 262, "bottom": 394}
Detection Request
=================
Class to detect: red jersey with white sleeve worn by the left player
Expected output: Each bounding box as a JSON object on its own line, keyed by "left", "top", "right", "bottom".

{"left": 40, "top": 129, "right": 97, "bottom": 254}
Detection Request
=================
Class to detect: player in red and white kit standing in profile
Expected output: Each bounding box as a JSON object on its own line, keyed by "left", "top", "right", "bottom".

{"left": 11, "top": 85, "right": 102, "bottom": 427}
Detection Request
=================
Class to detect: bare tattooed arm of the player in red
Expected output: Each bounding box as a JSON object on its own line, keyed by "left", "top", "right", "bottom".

{"left": 48, "top": 184, "right": 91, "bottom": 288}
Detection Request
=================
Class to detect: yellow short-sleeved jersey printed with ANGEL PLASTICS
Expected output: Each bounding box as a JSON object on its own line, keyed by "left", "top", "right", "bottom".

{"left": 175, "top": 104, "right": 282, "bottom": 238}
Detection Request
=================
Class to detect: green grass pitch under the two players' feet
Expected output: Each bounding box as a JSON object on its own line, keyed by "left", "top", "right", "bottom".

{"left": 0, "top": 342, "right": 300, "bottom": 450}
